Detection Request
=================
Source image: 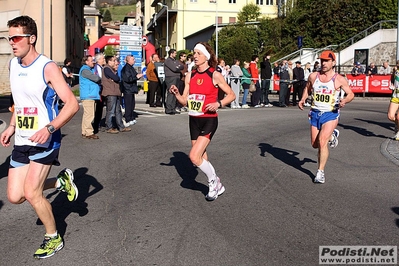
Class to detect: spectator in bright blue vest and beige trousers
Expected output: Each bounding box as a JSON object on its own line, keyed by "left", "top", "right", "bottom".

{"left": 79, "top": 55, "right": 101, "bottom": 139}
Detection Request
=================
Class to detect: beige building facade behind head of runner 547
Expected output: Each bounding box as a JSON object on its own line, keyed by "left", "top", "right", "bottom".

{"left": 0, "top": 0, "right": 91, "bottom": 94}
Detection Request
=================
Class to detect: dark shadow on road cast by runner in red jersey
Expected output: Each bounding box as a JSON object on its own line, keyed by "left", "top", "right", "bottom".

{"left": 161, "top": 152, "right": 209, "bottom": 195}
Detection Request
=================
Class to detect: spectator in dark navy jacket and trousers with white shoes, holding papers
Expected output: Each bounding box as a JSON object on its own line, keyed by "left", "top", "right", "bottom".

{"left": 121, "top": 55, "right": 143, "bottom": 126}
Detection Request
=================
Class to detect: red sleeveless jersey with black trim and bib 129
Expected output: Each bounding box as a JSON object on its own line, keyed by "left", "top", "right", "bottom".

{"left": 188, "top": 67, "right": 218, "bottom": 117}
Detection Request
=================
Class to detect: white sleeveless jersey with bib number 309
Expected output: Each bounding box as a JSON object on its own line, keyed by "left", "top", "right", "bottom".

{"left": 311, "top": 73, "right": 341, "bottom": 112}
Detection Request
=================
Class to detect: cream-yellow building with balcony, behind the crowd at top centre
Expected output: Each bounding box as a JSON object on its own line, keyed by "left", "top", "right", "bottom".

{"left": 145, "top": 0, "right": 282, "bottom": 55}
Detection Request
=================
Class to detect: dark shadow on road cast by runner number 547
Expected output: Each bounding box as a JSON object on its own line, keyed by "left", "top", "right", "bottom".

{"left": 36, "top": 167, "right": 103, "bottom": 236}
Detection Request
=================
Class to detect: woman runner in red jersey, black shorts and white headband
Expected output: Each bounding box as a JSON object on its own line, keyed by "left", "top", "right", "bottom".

{"left": 170, "top": 42, "right": 236, "bottom": 201}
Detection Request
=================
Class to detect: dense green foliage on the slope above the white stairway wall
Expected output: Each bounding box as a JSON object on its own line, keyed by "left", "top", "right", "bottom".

{"left": 214, "top": 0, "right": 398, "bottom": 61}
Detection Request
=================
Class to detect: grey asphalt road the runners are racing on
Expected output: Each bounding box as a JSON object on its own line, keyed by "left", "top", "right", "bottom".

{"left": 0, "top": 94, "right": 399, "bottom": 266}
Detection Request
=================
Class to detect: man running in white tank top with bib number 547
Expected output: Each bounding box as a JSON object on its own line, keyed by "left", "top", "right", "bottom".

{"left": 0, "top": 16, "right": 79, "bottom": 259}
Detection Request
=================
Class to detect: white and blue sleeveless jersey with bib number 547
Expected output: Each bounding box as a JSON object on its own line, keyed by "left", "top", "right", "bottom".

{"left": 10, "top": 55, "right": 61, "bottom": 149}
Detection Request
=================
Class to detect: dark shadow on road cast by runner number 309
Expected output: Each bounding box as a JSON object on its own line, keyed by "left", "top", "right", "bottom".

{"left": 259, "top": 143, "right": 317, "bottom": 180}
